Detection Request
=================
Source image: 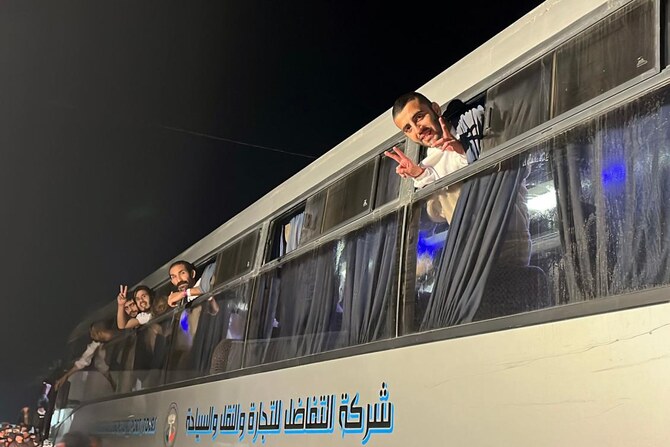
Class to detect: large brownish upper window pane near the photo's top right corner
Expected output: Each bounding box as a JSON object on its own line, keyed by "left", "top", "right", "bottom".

{"left": 553, "top": 0, "right": 656, "bottom": 116}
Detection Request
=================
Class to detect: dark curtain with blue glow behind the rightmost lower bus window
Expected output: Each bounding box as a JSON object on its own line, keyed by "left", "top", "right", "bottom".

{"left": 550, "top": 82, "right": 670, "bottom": 300}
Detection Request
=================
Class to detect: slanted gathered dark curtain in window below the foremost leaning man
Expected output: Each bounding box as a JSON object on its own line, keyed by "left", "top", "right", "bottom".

{"left": 421, "top": 159, "right": 526, "bottom": 330}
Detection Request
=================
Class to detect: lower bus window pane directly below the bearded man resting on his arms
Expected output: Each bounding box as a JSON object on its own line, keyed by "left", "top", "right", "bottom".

{"left": 167, "top": 283, "right": 250, "bottom": 383}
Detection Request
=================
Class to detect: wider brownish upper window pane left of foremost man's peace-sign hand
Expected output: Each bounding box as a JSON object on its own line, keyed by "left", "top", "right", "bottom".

{"left": 323, "top": 160, "right": 376, "bottom": 232}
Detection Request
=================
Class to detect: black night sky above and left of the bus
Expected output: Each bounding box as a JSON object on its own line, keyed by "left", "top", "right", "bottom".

{"left": 0, "top": 0, "right": 540, "bottom": 422}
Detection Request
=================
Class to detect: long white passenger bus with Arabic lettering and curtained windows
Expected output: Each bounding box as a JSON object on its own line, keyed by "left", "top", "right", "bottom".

{"left": 50, "top": 0, "right": 670, "bottom": 447}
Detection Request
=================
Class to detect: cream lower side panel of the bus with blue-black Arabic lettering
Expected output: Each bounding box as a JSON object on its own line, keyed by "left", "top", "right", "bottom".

{"left": 60, "top": 304, "right": 670, "bottom": 447}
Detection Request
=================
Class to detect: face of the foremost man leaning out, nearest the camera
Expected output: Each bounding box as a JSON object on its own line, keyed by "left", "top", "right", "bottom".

{"left": 393, "top": 99, "right": 442, "bottom": 147}
